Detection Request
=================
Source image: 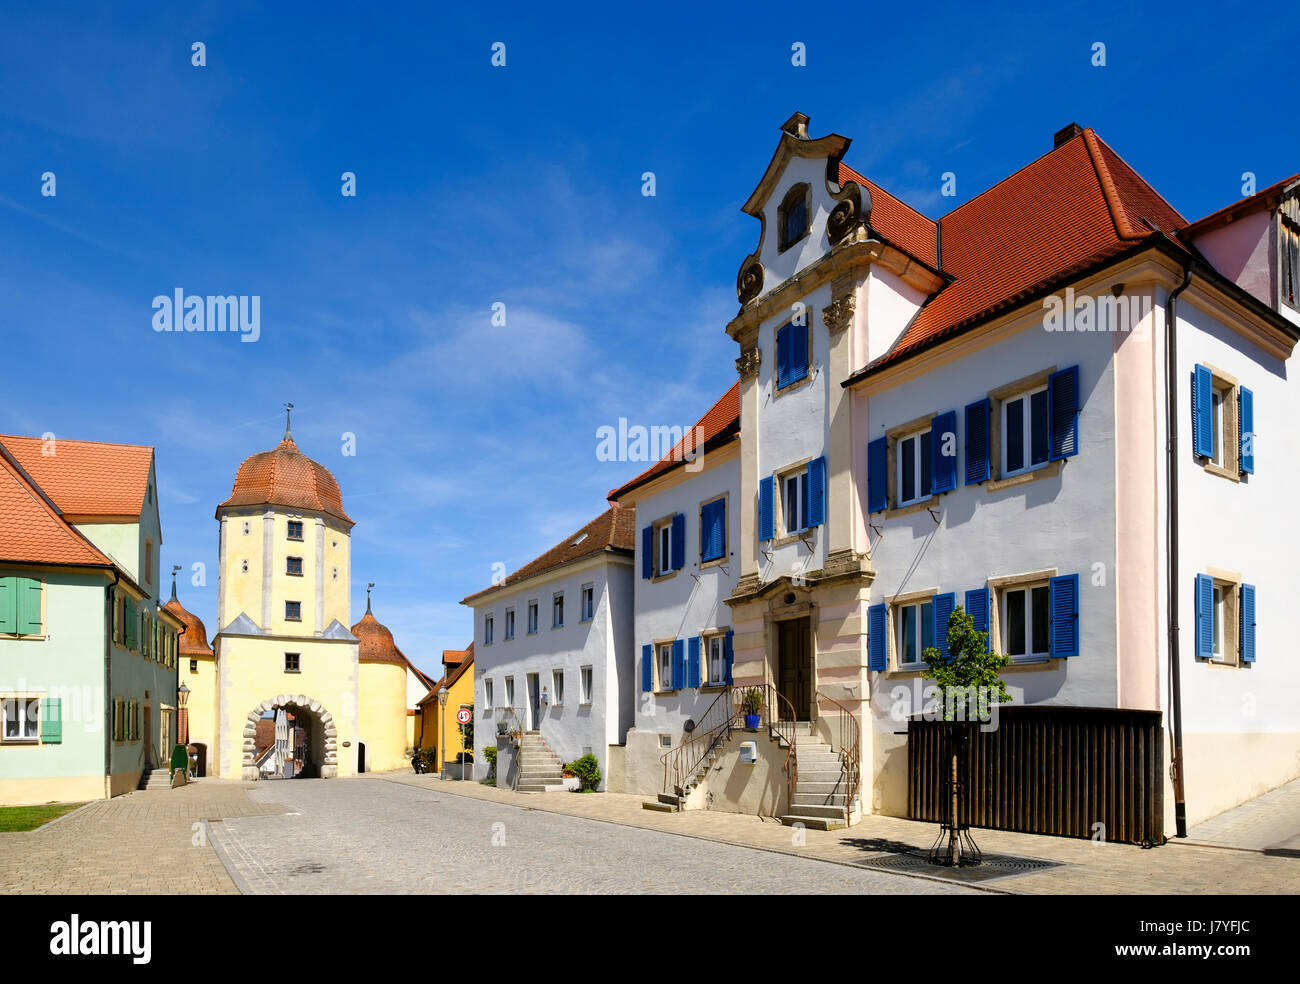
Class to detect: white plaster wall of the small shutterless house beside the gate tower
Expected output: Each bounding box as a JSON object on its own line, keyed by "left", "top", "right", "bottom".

{"left": 475, "top": 555, "right": 632, "bottom": 779}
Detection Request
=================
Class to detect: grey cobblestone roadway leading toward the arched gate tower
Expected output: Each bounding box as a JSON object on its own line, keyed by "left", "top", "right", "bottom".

{"left": 211, "top": 779, "right": 971, "bottom": 896}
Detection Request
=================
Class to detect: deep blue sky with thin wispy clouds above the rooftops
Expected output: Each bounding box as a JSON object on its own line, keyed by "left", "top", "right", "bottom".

{"left": 0, "top": 3, "right": 1300, "bottom": 672}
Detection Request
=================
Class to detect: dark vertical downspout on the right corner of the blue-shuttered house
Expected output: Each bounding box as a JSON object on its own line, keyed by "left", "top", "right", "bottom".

{"left": 1165, "top": 261, "right": 1195, "bottom": 837}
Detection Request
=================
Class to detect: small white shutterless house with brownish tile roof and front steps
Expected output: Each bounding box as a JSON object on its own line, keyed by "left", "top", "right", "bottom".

{"left": 463, "top": 506, "right": 636, "bottom": 789}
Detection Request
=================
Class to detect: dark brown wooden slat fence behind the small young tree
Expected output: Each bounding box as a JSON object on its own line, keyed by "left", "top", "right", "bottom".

{"left": 907, "top": 706, "right": 1165, "bottom": 844}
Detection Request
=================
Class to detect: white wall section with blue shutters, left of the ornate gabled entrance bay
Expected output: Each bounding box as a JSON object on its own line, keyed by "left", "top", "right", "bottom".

{"left": 632, "top": 456, "right": 740, "bottom": 745}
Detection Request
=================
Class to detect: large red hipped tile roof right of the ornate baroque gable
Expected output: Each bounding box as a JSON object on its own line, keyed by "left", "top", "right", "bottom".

{"left": 852, "top": 129, "right": 1187, "bottom": 378}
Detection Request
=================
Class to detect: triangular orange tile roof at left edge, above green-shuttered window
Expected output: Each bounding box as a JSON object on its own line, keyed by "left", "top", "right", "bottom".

{"left": 0, "top": 447, "right": 113, "bottom": 567}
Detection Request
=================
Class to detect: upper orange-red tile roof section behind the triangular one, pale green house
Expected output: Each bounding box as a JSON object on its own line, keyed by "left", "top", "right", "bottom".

{"left": 0, "top": 434, "right": 153, "bottom": 516}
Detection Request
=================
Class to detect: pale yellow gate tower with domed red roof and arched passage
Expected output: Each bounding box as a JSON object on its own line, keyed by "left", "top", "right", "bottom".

{"left": 173, "top": 425, "right": 415, "bottom": 780}
